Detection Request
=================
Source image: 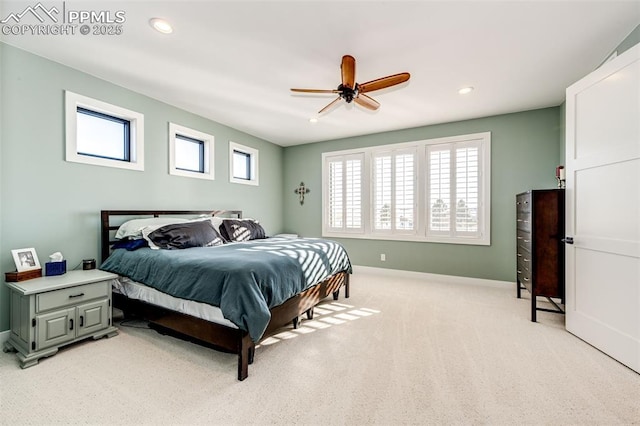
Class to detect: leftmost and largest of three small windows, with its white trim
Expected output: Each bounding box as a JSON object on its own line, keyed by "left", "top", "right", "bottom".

{"left": 65, "top": 91, "right": 144, "bottom": 171}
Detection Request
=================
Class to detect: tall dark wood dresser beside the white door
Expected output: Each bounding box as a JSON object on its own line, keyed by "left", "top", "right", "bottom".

{"left": 516, "top": 189, "right": 565, "bottom": 322}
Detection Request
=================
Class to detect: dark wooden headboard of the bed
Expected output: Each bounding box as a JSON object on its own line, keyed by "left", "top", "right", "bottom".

{"left": 100, "top": 210, "right": 242, "bottom": 262}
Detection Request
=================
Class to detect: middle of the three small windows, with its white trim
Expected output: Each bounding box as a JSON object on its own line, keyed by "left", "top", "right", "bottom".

{"left": 169, "top": 123, "right": 215, "bottom": 180}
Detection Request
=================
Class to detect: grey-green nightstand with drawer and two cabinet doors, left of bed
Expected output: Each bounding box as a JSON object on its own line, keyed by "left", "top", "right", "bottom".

{"left": 4, "top": 269, "right": 118, "bottom": 368}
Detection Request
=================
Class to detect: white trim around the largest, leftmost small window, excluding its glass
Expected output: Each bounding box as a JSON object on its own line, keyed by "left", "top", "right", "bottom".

{"left": 65, "top": 90, "right": 144, "bottom": 171}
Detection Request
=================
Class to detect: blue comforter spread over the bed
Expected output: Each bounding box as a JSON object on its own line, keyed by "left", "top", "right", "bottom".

{"left": 100, "top": 238, "right": 351, "bottom": 342}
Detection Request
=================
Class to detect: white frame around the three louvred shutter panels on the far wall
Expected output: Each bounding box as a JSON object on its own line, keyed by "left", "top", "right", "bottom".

{"left": 322, "top": 132, "right": 491, "bottom": 246}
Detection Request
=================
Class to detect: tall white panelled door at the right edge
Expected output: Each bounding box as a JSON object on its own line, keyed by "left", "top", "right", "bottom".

{"left": 566, "top": 41, "right": 640, "bottom": 372}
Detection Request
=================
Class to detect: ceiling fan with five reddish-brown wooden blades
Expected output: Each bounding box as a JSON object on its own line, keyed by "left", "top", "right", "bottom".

{"left": 291, "top": 55, "right": 411, "bottom": 114}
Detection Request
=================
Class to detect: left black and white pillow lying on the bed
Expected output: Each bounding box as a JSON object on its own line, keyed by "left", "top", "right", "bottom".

{"left": 142, "top": 220, "right": 224, "bottom": 249}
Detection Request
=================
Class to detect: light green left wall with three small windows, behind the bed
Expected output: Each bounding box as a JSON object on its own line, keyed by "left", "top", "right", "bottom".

{"left": 0, "top": 43, "right": 283, "bottom": 331}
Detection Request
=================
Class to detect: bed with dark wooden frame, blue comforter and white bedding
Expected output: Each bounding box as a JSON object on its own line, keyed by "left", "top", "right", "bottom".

{"left": 100, "top": 210, "right": 351, "bottom": 380}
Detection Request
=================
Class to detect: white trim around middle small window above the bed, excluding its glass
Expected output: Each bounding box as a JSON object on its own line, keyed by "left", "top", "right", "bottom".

{"left": 169, "top": 122, "right": 215, "bottom": 180}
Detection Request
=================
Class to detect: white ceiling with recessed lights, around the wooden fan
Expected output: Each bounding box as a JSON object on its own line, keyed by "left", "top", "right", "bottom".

{"left": 0, "top": 0, "right": 640, "bottom": 146}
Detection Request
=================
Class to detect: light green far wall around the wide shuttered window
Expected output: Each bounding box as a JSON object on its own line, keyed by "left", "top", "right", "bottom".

{"left": 284, "top": 107, "right": 561, "bottom": 281}
